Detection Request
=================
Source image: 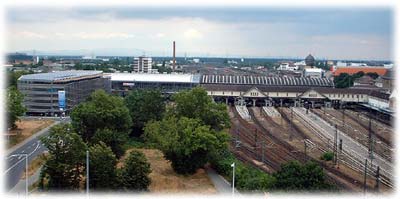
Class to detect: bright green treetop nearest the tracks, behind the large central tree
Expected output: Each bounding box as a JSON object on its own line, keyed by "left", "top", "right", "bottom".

{"left": 172, "top": 87, "right": 230, "bottom": 131}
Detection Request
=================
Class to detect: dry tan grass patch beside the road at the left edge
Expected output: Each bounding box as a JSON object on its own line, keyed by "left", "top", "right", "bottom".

{"left": 6, "top": 120, "right": 54, "bottom": 149}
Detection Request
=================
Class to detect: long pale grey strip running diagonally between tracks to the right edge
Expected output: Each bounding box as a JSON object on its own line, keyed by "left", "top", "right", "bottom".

{"left": 293, "top": 108, "right": 393, "bottom": 180}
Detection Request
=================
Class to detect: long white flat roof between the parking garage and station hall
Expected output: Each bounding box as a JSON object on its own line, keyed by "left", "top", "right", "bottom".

{"left": 106, "top": 73, "right": 200, "bottom": 83}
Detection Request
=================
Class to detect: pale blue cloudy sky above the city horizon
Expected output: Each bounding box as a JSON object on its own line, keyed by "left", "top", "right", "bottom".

{"left": 5, "top": 6, "right": 394, "bottom": 60}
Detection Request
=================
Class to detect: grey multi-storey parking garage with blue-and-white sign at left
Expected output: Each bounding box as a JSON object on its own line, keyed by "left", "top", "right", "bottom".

{"left": 17, "top": 70, "right": 111, "bottom": 116}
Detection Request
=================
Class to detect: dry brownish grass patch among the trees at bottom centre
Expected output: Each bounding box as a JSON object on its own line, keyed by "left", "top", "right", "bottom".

{"left": 117, "top": 148, "right": 217, "bottom": 194}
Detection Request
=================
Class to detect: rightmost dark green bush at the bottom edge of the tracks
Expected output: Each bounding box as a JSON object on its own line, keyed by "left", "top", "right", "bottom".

{"left": 273, "top": 161, "right": 332, "bottom": 191}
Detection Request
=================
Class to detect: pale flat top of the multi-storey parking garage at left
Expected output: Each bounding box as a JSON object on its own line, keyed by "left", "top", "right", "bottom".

{"left": 18, "top": 70, "right": 103, "bottom": 82}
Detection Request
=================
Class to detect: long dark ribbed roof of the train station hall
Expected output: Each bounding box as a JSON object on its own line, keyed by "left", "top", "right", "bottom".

{"left": 201, "top": 75, "right": 334, "bottom": 87}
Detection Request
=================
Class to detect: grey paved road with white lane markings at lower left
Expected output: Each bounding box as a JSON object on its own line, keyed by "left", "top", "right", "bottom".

{"left": 3, "top": 121, "right": 60, "bottom": 191}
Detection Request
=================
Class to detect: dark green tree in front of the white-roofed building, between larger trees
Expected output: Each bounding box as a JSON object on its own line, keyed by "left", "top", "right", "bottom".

{"left": 125, "top": 90, "right": 165, "bottom": 134}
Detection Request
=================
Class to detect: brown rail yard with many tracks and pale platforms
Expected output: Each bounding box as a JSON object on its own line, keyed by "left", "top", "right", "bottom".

{"left": 229, "top": 105, "right": 394, "bottom": 192}
